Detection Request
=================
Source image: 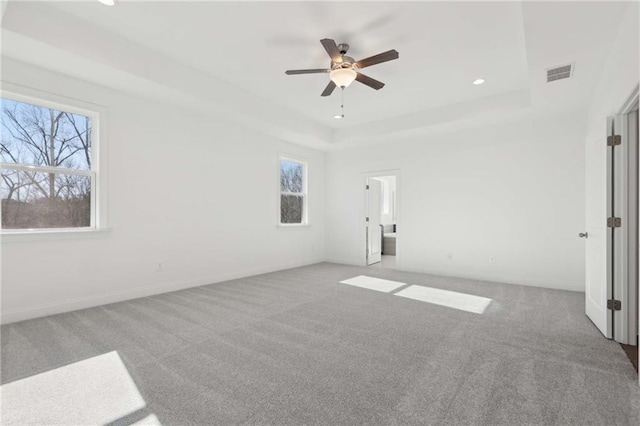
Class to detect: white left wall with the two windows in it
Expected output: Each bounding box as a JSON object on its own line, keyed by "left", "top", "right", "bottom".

{"left": 1, "top": 60, "right": 325, "bottom": 322}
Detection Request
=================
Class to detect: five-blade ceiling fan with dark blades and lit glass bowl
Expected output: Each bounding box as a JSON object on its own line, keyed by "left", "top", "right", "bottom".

{"left": 285, "top": 38, "right": 399, "bottom": 96}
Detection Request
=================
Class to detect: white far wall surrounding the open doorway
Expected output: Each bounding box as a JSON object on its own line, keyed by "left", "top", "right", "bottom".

{"left": 326, "top": 111, "right": 586, "bottom": 291}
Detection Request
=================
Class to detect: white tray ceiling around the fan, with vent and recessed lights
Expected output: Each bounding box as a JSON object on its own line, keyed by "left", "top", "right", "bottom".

{"left": 2, "top": 0, "right": 628, "bottom": 148}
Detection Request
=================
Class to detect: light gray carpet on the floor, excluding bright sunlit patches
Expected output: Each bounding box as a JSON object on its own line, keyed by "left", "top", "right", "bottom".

{"left": 1, "top": 263, "right": 640, "bottom": 425}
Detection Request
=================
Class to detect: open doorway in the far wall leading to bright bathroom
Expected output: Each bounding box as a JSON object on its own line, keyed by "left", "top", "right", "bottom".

{"left": 365, "top": 174, "right": 398, "bottom": 268}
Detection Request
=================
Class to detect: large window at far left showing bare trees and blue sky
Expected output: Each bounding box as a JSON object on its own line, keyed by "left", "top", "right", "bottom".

{"left": 0, "top": 94, "right": 97, "bottom": 232}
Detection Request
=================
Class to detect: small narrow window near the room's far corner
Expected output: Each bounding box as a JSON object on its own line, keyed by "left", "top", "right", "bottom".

{"left": 280, "top": 157, "right": 307, "bottom": 225}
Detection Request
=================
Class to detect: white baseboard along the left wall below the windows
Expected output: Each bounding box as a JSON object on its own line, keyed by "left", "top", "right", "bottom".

{"left": 0, "top": 258, "right": 325, "bottom": 324}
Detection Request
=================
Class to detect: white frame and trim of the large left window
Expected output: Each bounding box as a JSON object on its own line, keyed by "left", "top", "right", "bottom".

{"left": 0, "top": 87, "right": 107, "bottom": 236}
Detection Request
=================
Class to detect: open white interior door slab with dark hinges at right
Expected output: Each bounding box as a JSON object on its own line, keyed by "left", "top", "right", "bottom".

{"left": 585, "top": 116, "right": 613, "bottom": 338}
